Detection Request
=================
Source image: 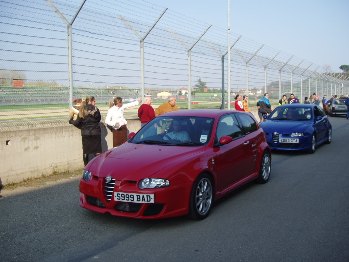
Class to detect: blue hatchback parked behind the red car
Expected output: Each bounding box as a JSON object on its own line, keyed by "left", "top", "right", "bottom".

{"left": 260, "top": 104, "right": 332, "bottom": 153}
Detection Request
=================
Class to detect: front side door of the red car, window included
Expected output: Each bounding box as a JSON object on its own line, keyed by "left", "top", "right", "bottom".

{"left": 214, "top": 114, "right": 250, "bottom": 191}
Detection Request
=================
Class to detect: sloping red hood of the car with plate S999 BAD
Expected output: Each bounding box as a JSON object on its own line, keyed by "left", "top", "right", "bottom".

{"left": 86, "top": 142, "right": 203, "bottom": 180}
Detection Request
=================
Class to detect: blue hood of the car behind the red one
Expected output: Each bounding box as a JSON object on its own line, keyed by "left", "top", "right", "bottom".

{"left": 260, "top": 120, "right": 311, "bottom": 133}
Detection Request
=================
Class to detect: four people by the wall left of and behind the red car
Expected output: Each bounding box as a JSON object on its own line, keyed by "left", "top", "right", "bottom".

{"left": 69, "top": 96, "right": 178, "bottom": 165}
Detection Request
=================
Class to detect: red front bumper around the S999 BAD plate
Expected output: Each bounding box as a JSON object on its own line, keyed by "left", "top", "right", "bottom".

{"left": 80, "top": 178, "right": 190, "bottom": 219}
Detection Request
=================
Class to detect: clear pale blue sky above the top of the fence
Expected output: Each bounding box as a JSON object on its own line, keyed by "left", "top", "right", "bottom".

{"left": 156, "top": 0, "right": 349, "bottom": 72}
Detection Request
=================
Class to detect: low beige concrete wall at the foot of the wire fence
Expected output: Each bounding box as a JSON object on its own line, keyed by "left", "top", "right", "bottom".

{"left": 0, "top": 119, "right": 140, "bottom": 185}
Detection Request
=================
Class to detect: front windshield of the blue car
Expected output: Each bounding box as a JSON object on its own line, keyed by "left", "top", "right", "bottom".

{"left": 269, "top": 107, "right": 313, "bottom": 121}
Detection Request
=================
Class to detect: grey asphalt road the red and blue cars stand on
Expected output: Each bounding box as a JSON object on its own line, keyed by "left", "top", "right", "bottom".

{"left": 0, "top": 118, "right": 349, "bottom": 262}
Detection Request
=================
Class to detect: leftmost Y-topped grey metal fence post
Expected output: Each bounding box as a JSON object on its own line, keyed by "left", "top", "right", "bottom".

{"left": 47, "top": 0, "right": 86, "bottom": 107}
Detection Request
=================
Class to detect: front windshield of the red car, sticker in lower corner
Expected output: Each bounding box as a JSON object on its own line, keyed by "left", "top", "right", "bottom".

{"left": 129, "top": 116, "right": 214, "bottom": 146}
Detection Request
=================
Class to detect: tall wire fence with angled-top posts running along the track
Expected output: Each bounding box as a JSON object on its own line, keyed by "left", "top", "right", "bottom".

{"left": 0, "top": 0, "right": 349, "bottom": 129}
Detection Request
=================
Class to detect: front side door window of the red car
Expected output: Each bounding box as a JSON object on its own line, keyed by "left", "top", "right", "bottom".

{"left": 216, "top": 114, "right": 243, "bottom": 141}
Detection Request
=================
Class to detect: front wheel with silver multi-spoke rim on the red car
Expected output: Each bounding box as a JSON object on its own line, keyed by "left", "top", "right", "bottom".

{"left": 189, "top": 174, "right": 213, "bottom": 220}
